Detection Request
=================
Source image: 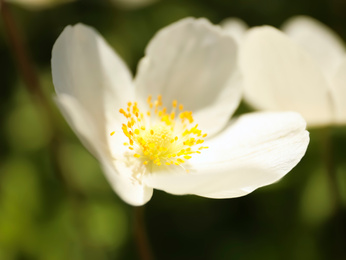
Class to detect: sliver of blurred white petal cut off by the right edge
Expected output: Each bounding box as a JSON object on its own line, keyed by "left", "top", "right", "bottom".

{"left": 332, "top": 56, "right": 346, "bottom": 124}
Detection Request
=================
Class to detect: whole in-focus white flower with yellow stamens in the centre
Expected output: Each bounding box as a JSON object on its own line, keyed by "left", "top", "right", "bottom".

{"left": 52, "top": 18, "right": 309, "bottom": 205}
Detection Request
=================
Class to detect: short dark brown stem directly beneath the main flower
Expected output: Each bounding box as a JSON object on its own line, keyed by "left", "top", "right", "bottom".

{"left": 134, "top": 206, "right": 154, "bottom": 260}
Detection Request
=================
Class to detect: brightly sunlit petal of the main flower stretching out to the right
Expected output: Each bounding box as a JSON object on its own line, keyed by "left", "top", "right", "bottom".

{"left": 145, "top": 112, "right": 309, "bottom": 198}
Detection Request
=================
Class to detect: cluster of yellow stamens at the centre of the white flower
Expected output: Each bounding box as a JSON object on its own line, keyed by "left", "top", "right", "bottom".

{"left": 111, "top": 95, "right": 208, "bottom": 166}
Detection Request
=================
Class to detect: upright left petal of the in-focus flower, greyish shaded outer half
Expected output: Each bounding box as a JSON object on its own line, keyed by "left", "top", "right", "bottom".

{"left": 52, "top": 24, "right": 134, "bottom": 136}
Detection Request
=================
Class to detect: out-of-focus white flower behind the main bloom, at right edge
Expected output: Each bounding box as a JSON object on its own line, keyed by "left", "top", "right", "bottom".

{"left": 239, "top": 16, "right": 346, "bottom": 127}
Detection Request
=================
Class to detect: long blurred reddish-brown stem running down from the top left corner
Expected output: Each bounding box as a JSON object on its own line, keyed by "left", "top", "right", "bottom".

{"left": 0, "top": 5, "right": 95, "bottom": 259}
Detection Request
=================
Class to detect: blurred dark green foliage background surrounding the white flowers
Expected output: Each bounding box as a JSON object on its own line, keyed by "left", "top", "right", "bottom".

{"left": 0, "top": 0, "right": 346, "bottom": 260}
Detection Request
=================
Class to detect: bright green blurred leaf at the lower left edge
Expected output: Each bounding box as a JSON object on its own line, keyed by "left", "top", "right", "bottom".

{"left": 0, "top": 158, "right": 41, "bottom": 249}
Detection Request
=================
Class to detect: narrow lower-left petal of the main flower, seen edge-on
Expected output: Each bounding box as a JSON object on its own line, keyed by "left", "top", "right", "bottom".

{"left": 56, "top": 94, "right": 153, "bottom": 206}
